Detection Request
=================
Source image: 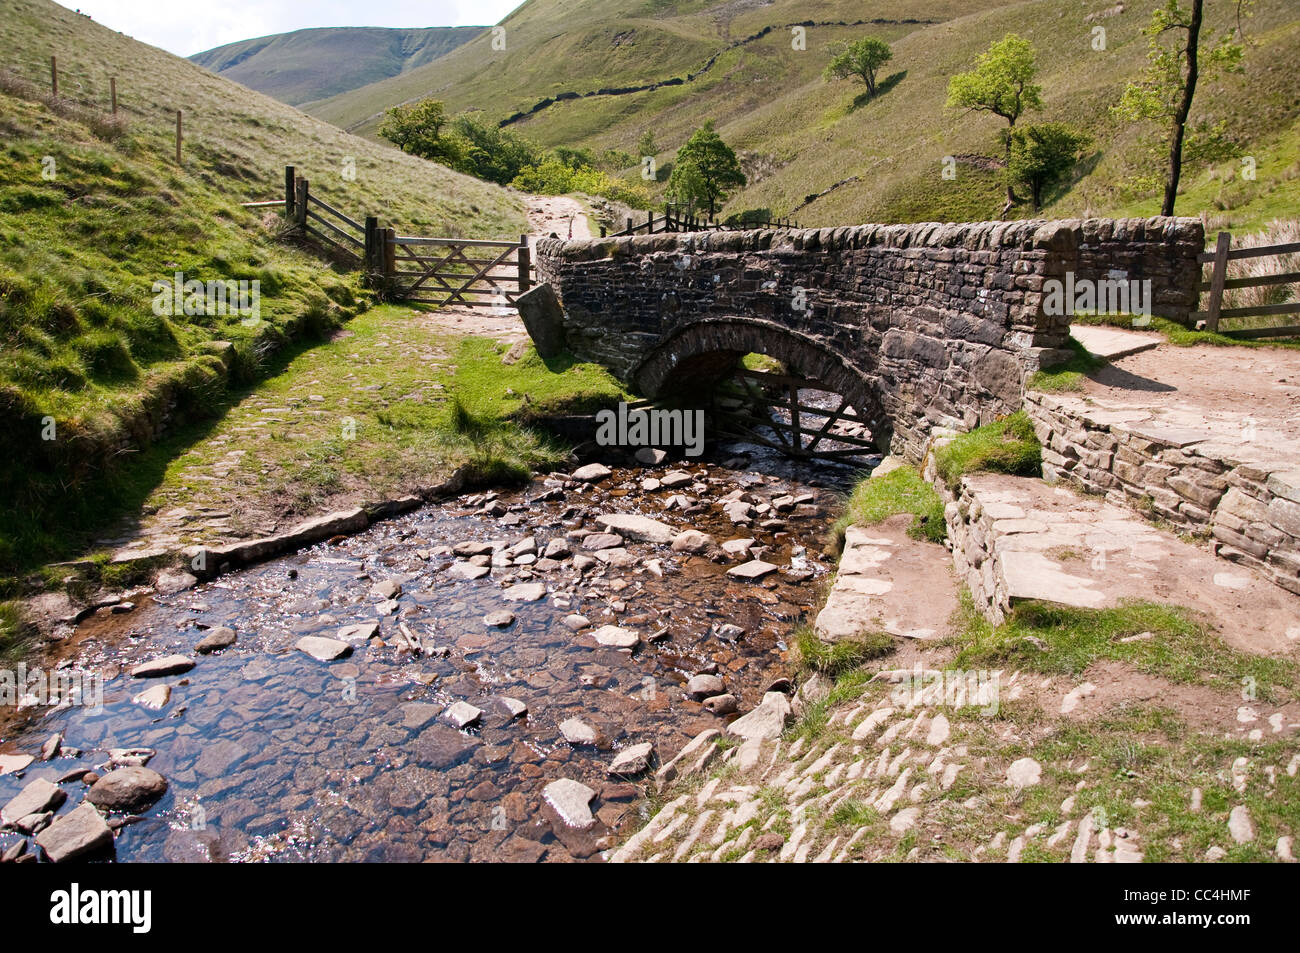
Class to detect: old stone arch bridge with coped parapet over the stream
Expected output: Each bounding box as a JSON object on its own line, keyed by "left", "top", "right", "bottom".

{"left": 520, "top": 218, "right": 1204, "bottom": 458}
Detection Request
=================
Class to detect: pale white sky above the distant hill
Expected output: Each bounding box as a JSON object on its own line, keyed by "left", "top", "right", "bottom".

{"left": 59, "top": 0, "right": 524, "bottom": 56}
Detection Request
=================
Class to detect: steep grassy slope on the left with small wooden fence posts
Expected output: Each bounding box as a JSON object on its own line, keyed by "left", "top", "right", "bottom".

{"left": 0, "top": 0, "right": 525, "bottom": 575}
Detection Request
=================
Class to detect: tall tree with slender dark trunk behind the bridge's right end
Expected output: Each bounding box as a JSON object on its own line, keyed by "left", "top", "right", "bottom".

{"left": 1114, "top": 0, "right": 1248, "bottom": 215}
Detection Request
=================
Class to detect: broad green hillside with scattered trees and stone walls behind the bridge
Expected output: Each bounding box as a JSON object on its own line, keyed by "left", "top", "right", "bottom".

{"left": 307, "top": 0, "right": 1300, "bottom": 228}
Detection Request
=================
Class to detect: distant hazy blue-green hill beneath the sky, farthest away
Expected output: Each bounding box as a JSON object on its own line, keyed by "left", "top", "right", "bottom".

{"left": 190, "top": 26, "right": 484, "bottom": 105}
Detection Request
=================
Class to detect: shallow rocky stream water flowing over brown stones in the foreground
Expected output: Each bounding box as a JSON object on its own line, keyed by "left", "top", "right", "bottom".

{"left": 0, "top": 450, "right": 873, "bottom": 861}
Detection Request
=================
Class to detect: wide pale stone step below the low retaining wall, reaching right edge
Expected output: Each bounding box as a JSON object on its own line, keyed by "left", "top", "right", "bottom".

{"left": 945, "top": 473, "right": 1300, "bottom": 653}
